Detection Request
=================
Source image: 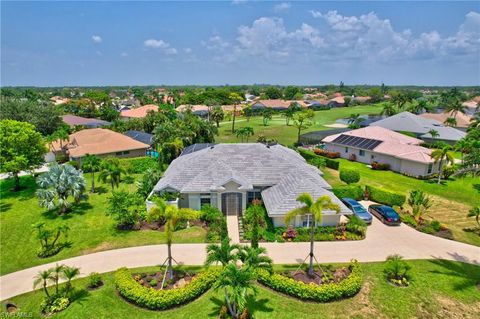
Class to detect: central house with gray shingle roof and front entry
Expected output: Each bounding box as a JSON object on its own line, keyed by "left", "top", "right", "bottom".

{"left": 152, "top": 143, "right": 351, "bottom": 227}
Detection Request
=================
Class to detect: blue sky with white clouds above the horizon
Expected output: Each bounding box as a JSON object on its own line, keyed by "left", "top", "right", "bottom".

{"left": 0, "top": 0, "right": 480, "bottom": 86}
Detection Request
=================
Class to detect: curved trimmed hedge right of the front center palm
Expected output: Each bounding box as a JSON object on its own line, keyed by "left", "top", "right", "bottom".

{"left": 257, "top": 261, "right": 363, "bottom": 302}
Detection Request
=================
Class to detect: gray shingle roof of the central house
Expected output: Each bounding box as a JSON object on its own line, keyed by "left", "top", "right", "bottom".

{"left": 154, "top": 143, "right": 349, "bottom": 215}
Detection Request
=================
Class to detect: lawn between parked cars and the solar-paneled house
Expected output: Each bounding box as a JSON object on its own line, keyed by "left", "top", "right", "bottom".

{"left": 322, "top": 159, "right": 480, "bottom": 246}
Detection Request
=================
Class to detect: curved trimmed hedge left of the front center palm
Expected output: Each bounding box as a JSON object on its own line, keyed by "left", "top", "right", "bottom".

{"left": 115, "top": 268, "right": 220, "bottom": 310}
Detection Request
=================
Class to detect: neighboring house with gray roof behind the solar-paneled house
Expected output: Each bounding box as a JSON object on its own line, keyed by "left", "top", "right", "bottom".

{"left": 370, "top": 112, "right": 466, "bottom": 144}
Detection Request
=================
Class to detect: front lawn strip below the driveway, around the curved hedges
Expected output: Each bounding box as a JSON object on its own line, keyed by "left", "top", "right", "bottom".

{"left": 7, "top": 260, "right": 480, "bottom": 319}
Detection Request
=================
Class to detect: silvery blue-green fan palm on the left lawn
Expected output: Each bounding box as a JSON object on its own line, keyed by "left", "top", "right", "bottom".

{"left": 36, "top": 164, "right": 86, "bottom": 214}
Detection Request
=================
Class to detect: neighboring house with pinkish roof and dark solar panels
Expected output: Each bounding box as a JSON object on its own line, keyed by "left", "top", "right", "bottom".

{"left": 322, "top": 126, "right": 438, "bottom": 177}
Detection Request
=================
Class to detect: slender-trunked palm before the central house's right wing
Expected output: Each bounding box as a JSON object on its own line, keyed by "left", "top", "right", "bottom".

{"left": 285, "top": 193, "right": 340, "bottom": 277}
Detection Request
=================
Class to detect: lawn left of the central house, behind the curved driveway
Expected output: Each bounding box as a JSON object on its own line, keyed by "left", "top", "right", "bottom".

{"left": 0, "top": 174, "right": 206, "bottom": 275}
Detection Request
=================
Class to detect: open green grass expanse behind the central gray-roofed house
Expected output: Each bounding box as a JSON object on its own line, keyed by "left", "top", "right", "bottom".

{"left": 215, "top": 104, "right": 381, "bottom": 145}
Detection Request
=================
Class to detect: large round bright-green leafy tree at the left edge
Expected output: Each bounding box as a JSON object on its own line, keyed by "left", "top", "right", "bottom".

{"left": 0, "top": 120, "right": 47, "bottom": 191}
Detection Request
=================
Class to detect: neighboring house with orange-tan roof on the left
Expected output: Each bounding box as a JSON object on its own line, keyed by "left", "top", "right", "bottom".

{"left": 51, "top": 128, "right": 150, "bottom": 160}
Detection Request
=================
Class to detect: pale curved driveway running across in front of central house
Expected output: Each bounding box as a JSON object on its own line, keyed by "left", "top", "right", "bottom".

{"left": 0, "top": 219, "right": 480, "bottom": 300}
